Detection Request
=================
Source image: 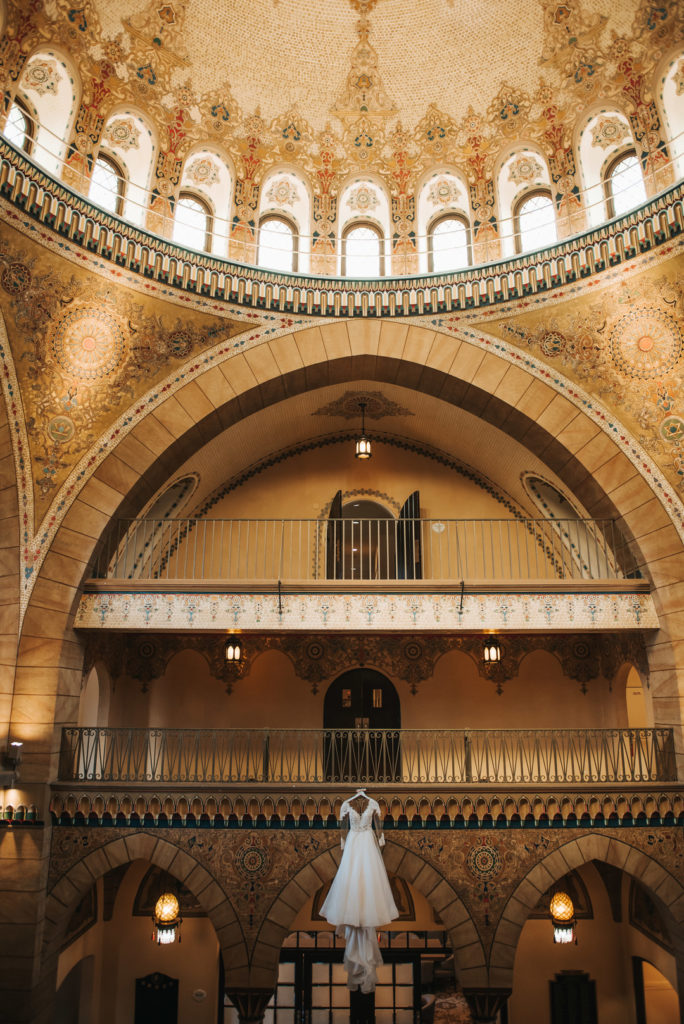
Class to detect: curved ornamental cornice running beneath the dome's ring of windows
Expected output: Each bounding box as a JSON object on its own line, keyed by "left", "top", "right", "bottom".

{"left": 0, "top": 139, "right": 684, "bottom": 317}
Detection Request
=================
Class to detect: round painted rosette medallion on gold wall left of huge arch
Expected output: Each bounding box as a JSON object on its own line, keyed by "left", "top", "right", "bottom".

{"left": 52, "top": 307, "right": 126, "bottom": 381}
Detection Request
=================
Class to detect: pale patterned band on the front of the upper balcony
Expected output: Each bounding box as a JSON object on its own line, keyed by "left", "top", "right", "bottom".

{"left": 74, "top": 585, "right": 658, "bottom": 633}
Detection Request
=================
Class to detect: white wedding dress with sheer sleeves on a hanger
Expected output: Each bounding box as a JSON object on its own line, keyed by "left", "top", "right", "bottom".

{"left": 320, "top": 798, "right": 399, "bottom": 992}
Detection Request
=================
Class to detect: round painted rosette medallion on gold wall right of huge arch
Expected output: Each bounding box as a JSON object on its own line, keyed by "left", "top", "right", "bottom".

{"left": 610, "top": 306, "right": 683, "bottom": 379}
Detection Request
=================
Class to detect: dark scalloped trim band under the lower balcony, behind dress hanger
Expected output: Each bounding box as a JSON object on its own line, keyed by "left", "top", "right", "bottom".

{"left": 49, "top": 782, "right": 684, "bottom": 831}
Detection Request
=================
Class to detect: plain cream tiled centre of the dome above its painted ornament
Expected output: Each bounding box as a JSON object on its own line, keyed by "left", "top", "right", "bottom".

{"left": 88, "top": 0, "right": 639, "bottom": 130}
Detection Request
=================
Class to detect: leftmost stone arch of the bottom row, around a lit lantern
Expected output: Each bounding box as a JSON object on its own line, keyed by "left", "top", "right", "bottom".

{"left": 41, "top": 831, "right": 248, "bottom": 991}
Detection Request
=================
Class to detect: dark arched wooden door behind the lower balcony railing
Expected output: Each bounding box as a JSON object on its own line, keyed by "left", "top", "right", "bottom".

{"left": 323, "top": 669, "right": 401, "bottom": 782}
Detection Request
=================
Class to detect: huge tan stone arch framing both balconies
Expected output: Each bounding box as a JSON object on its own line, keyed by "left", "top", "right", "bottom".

{"left": 9, "top": 319, "right": 684, "bottom": 786}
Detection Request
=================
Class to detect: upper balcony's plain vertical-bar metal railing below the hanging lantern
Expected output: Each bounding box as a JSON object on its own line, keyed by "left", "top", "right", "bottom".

{"left": 94, "top": 518, "right": 640, "bottom": 582}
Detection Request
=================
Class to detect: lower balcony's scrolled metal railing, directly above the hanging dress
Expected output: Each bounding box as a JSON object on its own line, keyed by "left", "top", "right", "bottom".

{"left": 59, "top": 728, "right": 677, "bottom": 785}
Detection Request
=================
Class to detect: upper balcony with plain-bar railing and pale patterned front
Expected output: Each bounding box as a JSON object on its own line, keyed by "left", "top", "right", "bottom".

{"left": 76, "top": 517, "right": 657, "bottom": 631}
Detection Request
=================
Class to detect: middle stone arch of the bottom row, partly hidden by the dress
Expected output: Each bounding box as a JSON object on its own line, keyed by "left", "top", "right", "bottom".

{"left": 250, "top": 837, "right": 487, "bottom": 989}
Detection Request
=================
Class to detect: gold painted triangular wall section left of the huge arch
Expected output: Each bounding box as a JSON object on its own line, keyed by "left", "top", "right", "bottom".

{"left": 0, "top": 228, "right": 245, "bottom": 527}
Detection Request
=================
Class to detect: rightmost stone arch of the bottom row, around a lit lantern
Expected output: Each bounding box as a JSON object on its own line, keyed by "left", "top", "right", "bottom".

{"left": 489, "top": 833, "right": 684, "bottom": 1007}
